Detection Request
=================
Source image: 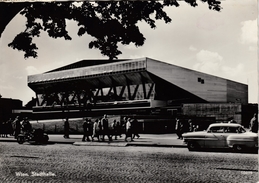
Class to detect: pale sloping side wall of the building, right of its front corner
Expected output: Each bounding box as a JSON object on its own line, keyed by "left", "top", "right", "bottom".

{"left": 147, "top": 58, "right": 248, "bottom": 104}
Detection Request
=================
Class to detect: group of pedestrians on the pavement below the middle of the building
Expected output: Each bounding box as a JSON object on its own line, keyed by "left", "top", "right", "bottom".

{"left": 82, "top": 114, "right": 140, "bottom": 141}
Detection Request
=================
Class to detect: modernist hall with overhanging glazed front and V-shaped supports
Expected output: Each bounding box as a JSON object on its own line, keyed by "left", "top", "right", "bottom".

{"left": 28, "top": 58, "right": 248, "bottom": 131}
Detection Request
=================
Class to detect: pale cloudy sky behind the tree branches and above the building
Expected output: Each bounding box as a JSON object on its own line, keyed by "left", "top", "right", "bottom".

{"left": 0, "top": 0, "right": 258, "bottom": 105}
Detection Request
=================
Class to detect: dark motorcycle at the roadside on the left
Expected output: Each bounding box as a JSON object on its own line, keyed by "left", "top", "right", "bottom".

{"left": 17, "top": 129, "right": 49, "bottom": 144}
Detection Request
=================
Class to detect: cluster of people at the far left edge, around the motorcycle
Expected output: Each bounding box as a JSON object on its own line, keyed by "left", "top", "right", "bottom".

{"left": 0, "top": 116, "right": 32, "bottom": 138}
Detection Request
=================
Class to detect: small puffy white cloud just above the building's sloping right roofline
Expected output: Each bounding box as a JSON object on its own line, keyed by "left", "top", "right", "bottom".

{"left": 193, "top": 50, "right": 223, "bottom": 74}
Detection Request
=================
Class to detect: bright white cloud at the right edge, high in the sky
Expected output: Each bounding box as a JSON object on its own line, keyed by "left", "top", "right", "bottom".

{"left": 240, "top": 19, "right": 257, "bottom": 44}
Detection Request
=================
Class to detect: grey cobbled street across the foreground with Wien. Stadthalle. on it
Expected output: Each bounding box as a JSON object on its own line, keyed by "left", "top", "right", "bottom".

{"left": 0, "top": 142, "right": 258, "bottom": 183}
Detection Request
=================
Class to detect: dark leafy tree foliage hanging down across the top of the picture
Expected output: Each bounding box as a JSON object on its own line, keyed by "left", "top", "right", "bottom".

{"left": 0, "top": 0, "right": 221, "bottom": 59}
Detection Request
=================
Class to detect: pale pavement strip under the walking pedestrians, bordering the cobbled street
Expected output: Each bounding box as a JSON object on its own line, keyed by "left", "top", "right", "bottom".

{"left": 0, "top": 134, "right": 187, "bottom": 148}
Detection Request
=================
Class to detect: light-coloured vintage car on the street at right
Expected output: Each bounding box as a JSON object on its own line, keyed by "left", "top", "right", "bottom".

{"left": 183, "top": 123, "right": 258, "bottom": 151}
